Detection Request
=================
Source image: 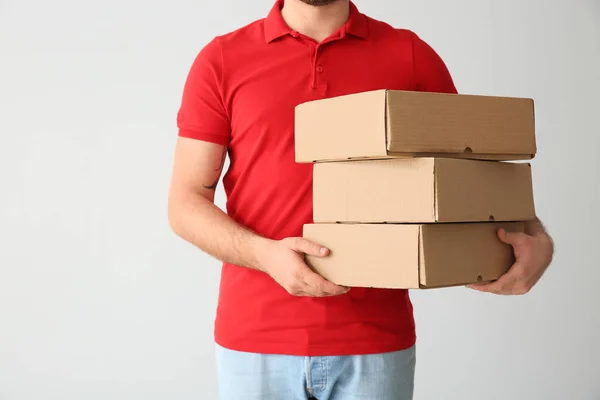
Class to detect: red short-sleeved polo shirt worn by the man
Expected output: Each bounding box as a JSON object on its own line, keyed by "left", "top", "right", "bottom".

{"left": 178, "top": 1, "right": 456, "bottom": 356}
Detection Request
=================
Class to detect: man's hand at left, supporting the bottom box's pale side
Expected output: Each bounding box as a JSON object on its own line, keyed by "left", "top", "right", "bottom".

{"left": 257, "top": 237, "right": 350, "bottom": 297}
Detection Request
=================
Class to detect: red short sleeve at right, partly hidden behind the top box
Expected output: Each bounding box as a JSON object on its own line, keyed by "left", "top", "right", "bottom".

{"left": 412, "top": 34, "right": 457, "bottom": 94}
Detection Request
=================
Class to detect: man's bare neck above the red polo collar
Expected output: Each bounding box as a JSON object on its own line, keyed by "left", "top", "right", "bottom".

{"left": 281, "top": 0, "right": 350, "bottom": 42}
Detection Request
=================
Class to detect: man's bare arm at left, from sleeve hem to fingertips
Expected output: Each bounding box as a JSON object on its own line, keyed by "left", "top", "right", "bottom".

{"left": 169, "top": 137, "right": 348, "bottom": 297}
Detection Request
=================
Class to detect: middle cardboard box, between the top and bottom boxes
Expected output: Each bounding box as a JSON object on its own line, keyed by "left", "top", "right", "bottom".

{"left": 313, "top": 158, "right": 535, "bottom": 223}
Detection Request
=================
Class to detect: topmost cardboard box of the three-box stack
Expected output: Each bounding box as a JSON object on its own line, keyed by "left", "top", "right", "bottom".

{"left": 295, "top": 90, "right": 536, "bottom": 163}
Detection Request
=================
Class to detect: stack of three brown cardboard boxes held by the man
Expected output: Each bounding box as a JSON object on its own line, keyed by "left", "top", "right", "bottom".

{"left": 295, "top": 90, "right": 536, "bottom": 288}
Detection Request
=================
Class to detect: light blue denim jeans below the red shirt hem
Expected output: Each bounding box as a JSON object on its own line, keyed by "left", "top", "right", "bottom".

{"left": 216, "top": 346, "right": 416, "bottom": 400}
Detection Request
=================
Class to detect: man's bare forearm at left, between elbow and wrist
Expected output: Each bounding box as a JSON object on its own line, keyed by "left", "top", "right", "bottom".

{"left": 169, "top": 195, "right": 270, "bottom": 270}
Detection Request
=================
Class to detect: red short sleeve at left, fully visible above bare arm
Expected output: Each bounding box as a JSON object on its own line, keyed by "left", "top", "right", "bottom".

{"left": 177, "top": 39, "right": 231, "bottom": 146}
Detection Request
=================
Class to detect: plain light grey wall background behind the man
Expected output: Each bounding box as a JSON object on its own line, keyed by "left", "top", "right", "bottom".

{"left": 0, "top": 0, "right": 600, "bottom": 400}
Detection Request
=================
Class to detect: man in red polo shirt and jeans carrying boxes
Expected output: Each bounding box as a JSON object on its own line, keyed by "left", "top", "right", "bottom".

{"left": 169, "top": 0, "right": 552, "bottom": 400}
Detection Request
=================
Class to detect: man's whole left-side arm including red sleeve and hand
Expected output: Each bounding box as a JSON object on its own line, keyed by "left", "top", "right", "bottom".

{"left": 169, "top": 39, "right": 347, "bottom": 296}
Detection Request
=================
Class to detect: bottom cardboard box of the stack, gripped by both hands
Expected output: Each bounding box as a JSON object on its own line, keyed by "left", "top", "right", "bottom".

{"left": 304, "top": 222, "right": 524, "bottom": 289}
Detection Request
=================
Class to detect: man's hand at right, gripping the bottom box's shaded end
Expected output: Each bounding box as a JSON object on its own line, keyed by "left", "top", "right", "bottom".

{"left": 467, "top": 220, "right": 554, "bottom": 295}
